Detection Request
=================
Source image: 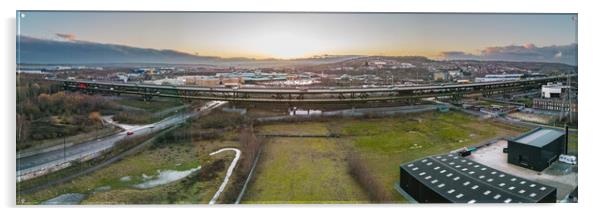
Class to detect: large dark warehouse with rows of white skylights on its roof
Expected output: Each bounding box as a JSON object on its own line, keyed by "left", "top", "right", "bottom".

{"left": 398, "top": 154, "right": 556, "bottom": 203}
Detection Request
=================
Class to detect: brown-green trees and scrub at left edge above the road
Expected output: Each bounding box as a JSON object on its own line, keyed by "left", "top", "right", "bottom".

{"left": 16, "top": 77, "right": 117, "bottom": 143}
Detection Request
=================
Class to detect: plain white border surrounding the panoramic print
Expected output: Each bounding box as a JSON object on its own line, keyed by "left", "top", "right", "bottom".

{"left": 0, "top": 0, "right": 602, "bottom": 216}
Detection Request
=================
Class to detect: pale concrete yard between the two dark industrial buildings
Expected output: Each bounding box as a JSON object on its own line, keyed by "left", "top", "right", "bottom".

{"left": 466, "top": 140, "right": 577, "bottom": 200}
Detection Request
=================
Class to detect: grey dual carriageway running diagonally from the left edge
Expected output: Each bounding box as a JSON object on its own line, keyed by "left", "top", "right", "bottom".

{"left": 17, "top": 101, "right": 226, "bottom": 181}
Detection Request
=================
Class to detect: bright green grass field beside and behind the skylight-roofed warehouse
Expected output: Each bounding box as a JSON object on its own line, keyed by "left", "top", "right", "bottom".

{"left": 338, "top": 112, "right": 525, "bottom": 202}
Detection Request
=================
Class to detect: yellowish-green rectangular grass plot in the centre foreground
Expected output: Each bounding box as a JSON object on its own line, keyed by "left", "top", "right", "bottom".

{"left": 243, "top": 138, "right": 368, "bottom": 203}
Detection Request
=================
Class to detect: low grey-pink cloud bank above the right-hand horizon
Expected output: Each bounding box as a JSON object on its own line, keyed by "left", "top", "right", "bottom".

{"left": 441, "top": 43, "right": 577, "bottom": 65}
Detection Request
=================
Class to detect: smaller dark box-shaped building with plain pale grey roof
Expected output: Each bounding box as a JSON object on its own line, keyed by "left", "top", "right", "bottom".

{"left": 507, "top": 128, "right": 566, "bottom": 171}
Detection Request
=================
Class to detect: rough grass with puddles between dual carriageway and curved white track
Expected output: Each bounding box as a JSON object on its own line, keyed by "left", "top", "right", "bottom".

{"left": 17, "top": 140, "right": 238, "bottom": 204}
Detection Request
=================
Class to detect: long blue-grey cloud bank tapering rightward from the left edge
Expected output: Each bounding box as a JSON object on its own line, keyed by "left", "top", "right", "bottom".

{"left": 17, "top": 36, "right": 356, "bottom": 66}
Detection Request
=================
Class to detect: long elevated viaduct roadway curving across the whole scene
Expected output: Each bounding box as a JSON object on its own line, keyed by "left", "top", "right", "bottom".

{"left": 55, "top": 75, "right": 576, "bottom": 104}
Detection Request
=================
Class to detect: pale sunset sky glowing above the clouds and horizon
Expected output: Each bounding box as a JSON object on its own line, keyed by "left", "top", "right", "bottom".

{"left": 18, "top": 12, "right": 577, "bottom": 58}
